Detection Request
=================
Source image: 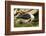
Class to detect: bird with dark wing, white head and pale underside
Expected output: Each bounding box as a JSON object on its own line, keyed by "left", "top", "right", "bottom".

{"left": 16, "top": 14, "right": 34, "bottom": 23}
